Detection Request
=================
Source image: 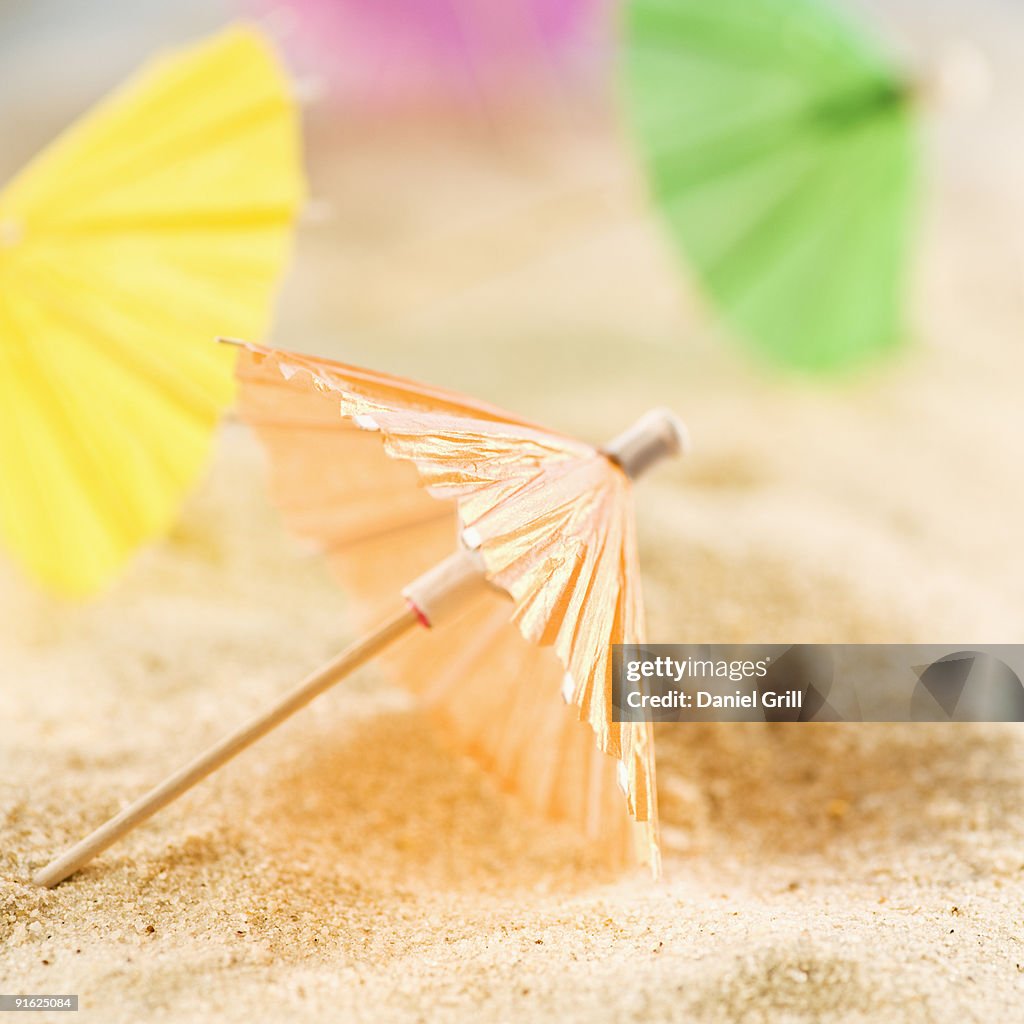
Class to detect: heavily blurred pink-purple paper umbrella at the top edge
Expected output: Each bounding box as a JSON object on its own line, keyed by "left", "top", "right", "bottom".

{"left": 266, "top": 0, "right": 607, "bottom": 103}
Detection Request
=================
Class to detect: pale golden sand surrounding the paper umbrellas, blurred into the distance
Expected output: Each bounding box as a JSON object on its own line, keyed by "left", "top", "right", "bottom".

{"left": 0, "top": 0, "right": 1024, "bottom": 1024}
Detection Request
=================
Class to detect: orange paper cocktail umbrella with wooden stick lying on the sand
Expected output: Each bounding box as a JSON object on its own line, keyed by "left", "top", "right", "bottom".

{"left": 36, "top": 345, "right": 685, "bottom": 885}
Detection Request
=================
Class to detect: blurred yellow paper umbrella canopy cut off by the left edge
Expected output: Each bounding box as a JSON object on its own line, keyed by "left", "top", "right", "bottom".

{"left": 0, "top": 27, "right": 303, "bottom": 596}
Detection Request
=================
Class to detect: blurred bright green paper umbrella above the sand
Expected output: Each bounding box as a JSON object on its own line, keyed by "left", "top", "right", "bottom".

{"left": 626, "top": 0, "right": 918, "bottom": 371}
